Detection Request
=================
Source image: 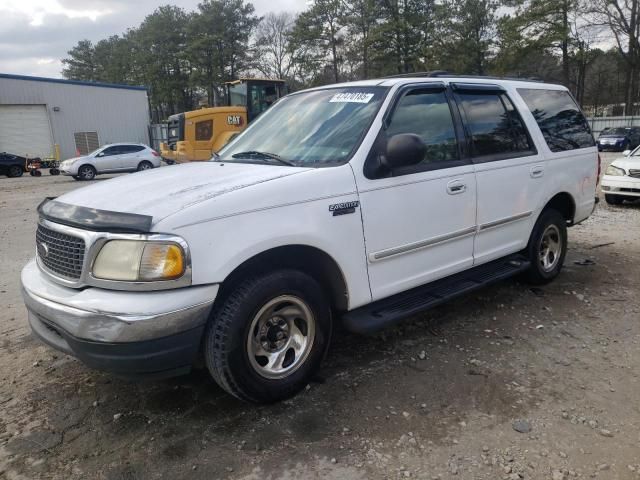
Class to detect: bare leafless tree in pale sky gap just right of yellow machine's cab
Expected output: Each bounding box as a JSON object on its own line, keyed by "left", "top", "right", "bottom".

{"left": 255, "top": 12, "right": 295, "bottom": 78}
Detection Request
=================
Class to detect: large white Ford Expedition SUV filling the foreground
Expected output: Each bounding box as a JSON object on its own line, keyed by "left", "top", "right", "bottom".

{"left": 22, "top": 76, "right": 599, "bottom": 402}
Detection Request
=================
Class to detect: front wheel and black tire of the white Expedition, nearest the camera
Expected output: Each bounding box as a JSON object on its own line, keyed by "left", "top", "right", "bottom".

{"left": 204, "top": 269, "right": 331, "bottom": 403}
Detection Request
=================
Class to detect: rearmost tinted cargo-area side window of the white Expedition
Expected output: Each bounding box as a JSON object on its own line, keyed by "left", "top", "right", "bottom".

{"left": 518, "top": 88, "right": 595, "bottom": 152}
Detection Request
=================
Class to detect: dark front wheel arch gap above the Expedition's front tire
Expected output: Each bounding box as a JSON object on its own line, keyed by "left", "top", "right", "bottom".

{"left": 218, "top": 245, "right": 349, "bottom": 311}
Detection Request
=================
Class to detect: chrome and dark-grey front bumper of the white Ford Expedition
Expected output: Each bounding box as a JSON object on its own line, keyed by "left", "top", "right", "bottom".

{"left": 22, "top": 261, "right": 218, "bottom": 377}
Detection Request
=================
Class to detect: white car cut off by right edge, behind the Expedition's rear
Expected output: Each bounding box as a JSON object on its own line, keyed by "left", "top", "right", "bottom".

{"left": 602, "top": 147, "right": 640, "bottom": 205}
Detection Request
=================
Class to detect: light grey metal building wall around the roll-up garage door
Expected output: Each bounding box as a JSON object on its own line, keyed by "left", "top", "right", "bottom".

{"left": 0, "top": 76, "right": 149, "bottom": 159}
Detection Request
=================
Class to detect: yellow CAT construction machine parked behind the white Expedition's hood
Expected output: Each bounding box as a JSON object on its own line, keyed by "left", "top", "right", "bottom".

{"left": 160, "top": 78, "right": 286, "bottom": 163}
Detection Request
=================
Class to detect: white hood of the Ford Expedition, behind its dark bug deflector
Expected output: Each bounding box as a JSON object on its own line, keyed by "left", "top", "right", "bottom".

{"left": 57, "top": 162, "right": 310, "bottom": 224}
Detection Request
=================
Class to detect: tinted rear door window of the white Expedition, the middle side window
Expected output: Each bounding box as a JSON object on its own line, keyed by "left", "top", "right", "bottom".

{"left": 458, "top": 92, "right": 535, "bottom": 160}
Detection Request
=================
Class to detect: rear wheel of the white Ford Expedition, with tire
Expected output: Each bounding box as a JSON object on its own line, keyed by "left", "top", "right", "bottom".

{"left": 525, "top": 209, "right": 567, "bottom": 285}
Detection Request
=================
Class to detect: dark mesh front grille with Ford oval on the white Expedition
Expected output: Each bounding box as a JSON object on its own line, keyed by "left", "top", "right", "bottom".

{"left": 36, "top": 225, "right": 85, "bottom": 280}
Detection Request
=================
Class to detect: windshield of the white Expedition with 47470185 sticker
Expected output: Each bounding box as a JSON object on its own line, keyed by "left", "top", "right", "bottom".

{"left": 213, "top": 87, "right": 388, "bottom": 167}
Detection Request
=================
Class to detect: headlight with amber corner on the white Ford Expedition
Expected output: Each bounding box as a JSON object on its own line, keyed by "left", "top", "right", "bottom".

{"left": 92, "top": 240, "right": 187, "bottom": 282}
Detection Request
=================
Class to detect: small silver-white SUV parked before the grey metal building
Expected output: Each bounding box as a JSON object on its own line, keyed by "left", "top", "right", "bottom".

{"left": 60, "top": 143, "right": 161, "bottom": 180}
